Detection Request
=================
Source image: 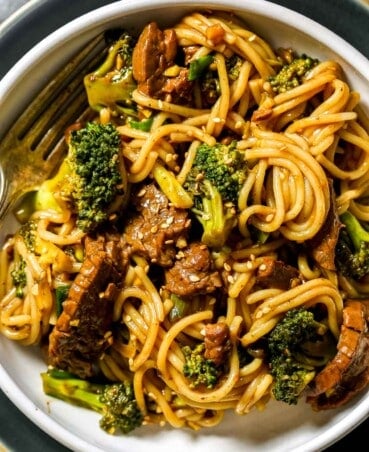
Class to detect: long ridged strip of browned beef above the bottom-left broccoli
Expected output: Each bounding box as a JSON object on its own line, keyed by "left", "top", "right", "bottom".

{"left": 48, "top": 236, "right": 123, "bottom": 378}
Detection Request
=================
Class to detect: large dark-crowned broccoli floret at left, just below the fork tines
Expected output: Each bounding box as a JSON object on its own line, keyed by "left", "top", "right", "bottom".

{"left": 35, "top": 123, "right": 128, "bottom": 232}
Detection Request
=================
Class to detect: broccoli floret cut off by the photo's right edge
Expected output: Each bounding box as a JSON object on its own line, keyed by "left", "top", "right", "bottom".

{"left": 335, "top": 212, "right": 369, "bottom": 280}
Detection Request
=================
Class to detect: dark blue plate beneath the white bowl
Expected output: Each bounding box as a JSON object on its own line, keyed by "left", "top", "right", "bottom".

{"left": 0, "top": 0, "right": 369, "bottom": 452}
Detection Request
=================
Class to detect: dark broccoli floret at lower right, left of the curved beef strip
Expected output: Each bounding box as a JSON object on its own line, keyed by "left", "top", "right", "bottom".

{"left": 267, "top": 308, "right": 335, "bottom": 405}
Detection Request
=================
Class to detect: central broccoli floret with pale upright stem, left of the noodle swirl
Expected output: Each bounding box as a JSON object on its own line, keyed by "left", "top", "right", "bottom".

{"left": 183, "top": 141, "right": 247, "bottom": 248}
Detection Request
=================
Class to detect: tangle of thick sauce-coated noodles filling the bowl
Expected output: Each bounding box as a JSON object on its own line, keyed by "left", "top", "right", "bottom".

{"left": 0, "top": 9, "right": 369, "bottom": 429}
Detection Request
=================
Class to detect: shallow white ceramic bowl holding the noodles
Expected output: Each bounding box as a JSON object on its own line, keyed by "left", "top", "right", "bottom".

{"left": 0, "top": 0, "right": 369, "bottom": 452}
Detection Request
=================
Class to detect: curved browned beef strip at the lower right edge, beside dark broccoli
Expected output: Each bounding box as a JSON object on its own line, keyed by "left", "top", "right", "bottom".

{"left": 307, "top": 300, "right": 369, "bottom": 411}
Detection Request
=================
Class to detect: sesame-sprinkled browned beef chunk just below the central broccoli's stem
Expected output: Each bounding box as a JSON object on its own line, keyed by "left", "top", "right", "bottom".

{"left": 165, "top": 242, "right": 222, "bottom": 296}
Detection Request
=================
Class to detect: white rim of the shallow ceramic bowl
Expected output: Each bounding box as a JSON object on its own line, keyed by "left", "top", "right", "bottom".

{"left": 0, "top": 0, "right": 369, "bottom": 452}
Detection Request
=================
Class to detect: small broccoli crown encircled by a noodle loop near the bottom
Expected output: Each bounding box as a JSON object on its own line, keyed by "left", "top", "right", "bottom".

{"left": 182, "top": 343, "right": 221, "bottom": 389}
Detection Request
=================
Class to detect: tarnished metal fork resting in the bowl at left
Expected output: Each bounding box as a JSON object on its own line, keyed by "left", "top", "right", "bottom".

{"left": 0, "top": 35, "right": 105, "bottom": 226}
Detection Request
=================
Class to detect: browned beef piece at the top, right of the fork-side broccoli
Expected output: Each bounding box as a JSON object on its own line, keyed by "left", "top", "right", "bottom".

{"left": 132, "top": 22, "right": 193, "bottom": 103}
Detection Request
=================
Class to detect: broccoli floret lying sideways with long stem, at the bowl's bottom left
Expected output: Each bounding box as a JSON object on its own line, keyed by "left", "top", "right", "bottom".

{"left": 41, "top": 370, "right": 143, "bottom": 434}
